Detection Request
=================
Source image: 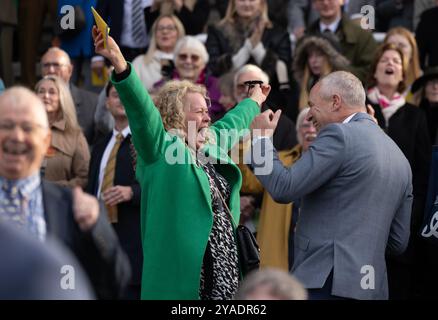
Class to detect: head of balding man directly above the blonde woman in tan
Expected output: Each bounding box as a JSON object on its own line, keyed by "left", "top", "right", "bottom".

{"left": 41, "top": 47, "right": 73, "bottom": 83}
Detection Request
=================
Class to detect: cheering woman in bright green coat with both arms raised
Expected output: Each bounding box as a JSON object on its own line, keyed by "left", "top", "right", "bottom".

{"left": 93, "top": 28, "right": 270, "bottom": 299}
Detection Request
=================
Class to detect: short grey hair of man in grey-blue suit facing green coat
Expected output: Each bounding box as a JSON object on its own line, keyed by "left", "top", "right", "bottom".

{"left": 319, "top": 71, "right": 366, "bottom": 107}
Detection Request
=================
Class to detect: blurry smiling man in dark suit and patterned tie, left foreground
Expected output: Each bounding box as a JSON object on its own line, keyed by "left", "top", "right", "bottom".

{"left": 0, "top": 87, "right": 130, "bottom": 299}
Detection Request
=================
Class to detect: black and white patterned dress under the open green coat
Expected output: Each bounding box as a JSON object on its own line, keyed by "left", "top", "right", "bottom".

{"left": 199, "top": 163, "right": 239, "bottom": 300}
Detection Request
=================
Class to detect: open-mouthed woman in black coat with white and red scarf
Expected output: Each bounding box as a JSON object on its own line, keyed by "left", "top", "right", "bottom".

{"left": 364, "top": 43, "right": 431, "bottom": 299}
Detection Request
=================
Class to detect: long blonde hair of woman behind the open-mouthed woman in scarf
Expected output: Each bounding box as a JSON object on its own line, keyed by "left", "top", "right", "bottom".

{"left": 383, "top": 27, "right": 421, "bottom": 87}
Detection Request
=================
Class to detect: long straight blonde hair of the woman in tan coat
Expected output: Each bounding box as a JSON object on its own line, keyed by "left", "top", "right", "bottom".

{"left": 35, "top": 75, "right": 81, "bottom": 131}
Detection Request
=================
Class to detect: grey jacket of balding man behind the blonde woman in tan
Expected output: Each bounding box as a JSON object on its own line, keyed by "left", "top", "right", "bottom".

{"left": 70, "top": 83, "right": 97, "bottom": 145}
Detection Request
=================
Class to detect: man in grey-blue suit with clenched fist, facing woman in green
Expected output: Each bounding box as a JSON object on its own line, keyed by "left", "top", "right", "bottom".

{"left": 248, "top": 71, "right": 412, "bottom": 299}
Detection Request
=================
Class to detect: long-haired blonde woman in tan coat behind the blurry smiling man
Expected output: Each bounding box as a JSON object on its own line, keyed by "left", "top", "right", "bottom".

{"left": 35, "top": 76, "right": 90, "bottom": 187}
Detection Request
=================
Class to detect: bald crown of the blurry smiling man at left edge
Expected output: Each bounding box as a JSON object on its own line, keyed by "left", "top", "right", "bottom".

{"left": 0, "top": 86, "right": 49, "bottom": 128}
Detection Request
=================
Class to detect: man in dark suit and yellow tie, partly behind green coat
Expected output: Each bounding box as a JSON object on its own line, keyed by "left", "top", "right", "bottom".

{"left": 86, "top": 83, "right": 143, "bottom": 299}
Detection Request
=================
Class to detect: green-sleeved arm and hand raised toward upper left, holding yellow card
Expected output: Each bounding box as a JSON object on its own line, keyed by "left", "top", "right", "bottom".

{"left": 93, "top": 27, "right": 167, "bottom": 163}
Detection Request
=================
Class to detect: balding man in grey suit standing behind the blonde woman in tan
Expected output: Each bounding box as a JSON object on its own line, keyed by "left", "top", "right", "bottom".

{"left": 41, "top": 47, "right": 97, "bottom": 146}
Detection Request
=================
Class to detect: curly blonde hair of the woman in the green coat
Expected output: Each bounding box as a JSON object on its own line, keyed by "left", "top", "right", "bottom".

{"left": 154, "top": 80, "right": 210, "bottom": 135}
